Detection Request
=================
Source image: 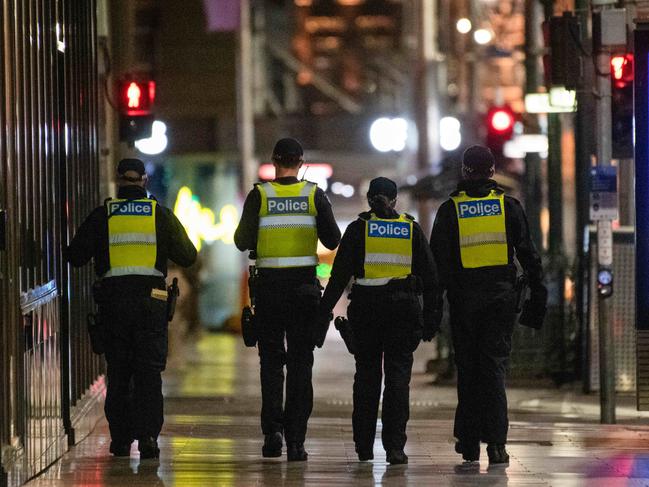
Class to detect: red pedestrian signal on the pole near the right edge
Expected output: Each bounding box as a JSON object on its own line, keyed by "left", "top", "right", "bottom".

{"left": 611, "top": 54, "right": 633, "bottom": 159}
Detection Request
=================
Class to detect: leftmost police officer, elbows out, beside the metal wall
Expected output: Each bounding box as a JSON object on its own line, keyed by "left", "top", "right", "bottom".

{"left": 65, "top": 159, "right": 196, "bottom": 458}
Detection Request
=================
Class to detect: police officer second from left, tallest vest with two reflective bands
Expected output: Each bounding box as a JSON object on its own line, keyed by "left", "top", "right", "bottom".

{"left": 234, "top": 138, "right": 340, "bottom": 461}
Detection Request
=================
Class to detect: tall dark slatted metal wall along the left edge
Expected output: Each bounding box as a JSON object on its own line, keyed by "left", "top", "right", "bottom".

{"left": 0, "top": 0, "right": 102, "bottom": 486}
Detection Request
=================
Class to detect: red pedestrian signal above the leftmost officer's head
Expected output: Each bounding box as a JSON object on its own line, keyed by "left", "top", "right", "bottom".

{"left": 117, "top": 77, "right": 155, "bottom": 143}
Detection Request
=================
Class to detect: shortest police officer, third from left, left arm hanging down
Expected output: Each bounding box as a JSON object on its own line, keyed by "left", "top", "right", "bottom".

{"left": 316, "top": 177, "right": 440, "bottom": 464}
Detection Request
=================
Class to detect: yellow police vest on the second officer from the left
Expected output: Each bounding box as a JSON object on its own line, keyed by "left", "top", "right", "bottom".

{"left": 256, "top": 181, "right": 318, "bottom": 268}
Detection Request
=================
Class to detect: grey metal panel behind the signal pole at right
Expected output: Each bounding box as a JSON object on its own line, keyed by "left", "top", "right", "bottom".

{"left": 588, "top": 229, "right": 636, "bottom": 392}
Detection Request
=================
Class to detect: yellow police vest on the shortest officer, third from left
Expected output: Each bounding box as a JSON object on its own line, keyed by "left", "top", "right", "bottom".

{"left": 355, "top": 213, "right": 413, "bottom": 286}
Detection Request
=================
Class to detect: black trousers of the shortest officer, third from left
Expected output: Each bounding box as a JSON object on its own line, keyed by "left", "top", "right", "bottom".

{"left": 347, "top": 290, "right": 422, "bottom": 451}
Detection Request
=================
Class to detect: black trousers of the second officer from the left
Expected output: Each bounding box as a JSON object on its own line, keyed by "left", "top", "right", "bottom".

{"left": 255, "top": 282, "right": 320, "bottom": 443}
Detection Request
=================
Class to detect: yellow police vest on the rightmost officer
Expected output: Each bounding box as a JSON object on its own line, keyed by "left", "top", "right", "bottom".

{"left": 451, "top": 190, "right": 509, "bottom": 269}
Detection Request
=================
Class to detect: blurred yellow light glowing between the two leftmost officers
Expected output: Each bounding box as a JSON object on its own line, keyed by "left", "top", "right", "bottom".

{"left": 174, "top": 186, "right": 239, "bottom": 250}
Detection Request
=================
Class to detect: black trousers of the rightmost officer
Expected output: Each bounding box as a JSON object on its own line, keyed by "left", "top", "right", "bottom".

{"left": 451, "top": 298, "right": 516, "bottom": 444}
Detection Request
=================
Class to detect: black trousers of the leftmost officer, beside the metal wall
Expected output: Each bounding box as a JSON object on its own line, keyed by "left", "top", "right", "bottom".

{"left": 101, "top": 276, "right": 167, "bottom": 444}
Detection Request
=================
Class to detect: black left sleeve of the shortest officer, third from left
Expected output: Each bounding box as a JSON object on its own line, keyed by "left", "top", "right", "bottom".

{"left": 320, "top": 220, "right": 365, "bottom": 315}
